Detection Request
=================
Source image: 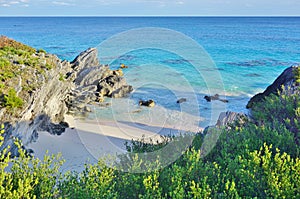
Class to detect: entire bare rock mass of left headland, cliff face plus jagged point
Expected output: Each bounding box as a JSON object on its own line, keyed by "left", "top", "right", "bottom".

{"left": 0, "top": 39, "right": 132, "bottom": 156}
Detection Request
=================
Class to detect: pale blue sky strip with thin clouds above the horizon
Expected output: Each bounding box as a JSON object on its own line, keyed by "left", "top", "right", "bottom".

{"left": 0, "top": 0, "right": 300, "bottom": 16}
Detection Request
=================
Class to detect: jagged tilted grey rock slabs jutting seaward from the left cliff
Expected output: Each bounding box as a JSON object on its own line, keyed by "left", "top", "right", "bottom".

{"left": 67, "top": 48, "right": 133, "bottom": 115}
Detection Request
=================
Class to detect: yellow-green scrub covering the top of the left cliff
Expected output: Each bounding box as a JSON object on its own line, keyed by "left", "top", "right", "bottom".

{"left": 0, "top": 43, "right": 54, "bottom": 117}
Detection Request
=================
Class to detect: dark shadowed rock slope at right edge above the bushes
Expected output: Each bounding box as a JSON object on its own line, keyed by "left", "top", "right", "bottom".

{"left": 246, "top": 66, "right": 299, "bottom": 108}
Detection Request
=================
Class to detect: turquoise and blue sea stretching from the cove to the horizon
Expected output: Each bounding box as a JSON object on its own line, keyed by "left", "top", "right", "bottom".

{"left": 0, "top": 17, "right": 300, "bottom": 126}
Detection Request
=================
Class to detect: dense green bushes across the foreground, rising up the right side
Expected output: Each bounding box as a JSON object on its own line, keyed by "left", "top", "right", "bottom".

{"left": 0, "top": 86, "right": 300, "bottom": 199}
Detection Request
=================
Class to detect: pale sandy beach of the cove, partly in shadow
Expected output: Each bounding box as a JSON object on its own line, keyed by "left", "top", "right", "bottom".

{"left": 27, "top": 116, "right": 200, "bottom": 172}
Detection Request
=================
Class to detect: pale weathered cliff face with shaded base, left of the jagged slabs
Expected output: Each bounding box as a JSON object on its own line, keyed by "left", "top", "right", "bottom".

{"left": 0, "top": 55, "right": 73, "bottom": 156}
